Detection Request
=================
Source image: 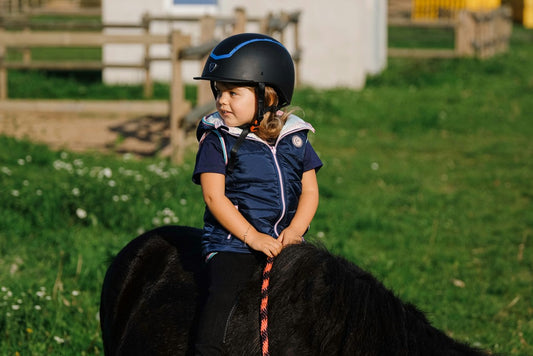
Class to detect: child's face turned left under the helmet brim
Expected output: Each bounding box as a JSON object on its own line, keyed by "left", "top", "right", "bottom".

{"left": 215, "top": 82, "right": 256, "bottom": 127}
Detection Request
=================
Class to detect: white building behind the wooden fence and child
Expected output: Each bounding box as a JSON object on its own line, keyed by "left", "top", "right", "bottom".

{"left": 102, "top": 0, "right": 387, "bottom": 88}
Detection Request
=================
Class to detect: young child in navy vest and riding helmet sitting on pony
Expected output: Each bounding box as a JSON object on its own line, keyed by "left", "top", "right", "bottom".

{"left": 193, "top": 33, "right": 322, "bottom": 355}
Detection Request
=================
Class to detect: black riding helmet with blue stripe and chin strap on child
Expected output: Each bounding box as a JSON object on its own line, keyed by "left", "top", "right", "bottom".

{"left": 194, "top": 33, "right": 294, "bottom": 131}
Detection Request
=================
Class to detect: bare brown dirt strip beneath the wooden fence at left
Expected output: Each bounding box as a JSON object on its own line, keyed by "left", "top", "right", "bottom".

{"left": 0, "top": 112, "right": 178, "bottom": 156}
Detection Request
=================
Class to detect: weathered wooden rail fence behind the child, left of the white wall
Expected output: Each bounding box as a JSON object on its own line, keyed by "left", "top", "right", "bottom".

{"left": 0, "top": 9, "right": 300, "bottom": 163}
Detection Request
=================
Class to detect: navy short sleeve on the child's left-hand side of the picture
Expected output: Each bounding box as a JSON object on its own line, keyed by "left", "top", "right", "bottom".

{"left": 192, "top": 133, "right": 226, "bottom": 184}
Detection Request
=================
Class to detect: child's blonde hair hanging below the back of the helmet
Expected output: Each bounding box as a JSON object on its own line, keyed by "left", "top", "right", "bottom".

{"left": 255, "top": 86, "right": 294, "bottom": 142}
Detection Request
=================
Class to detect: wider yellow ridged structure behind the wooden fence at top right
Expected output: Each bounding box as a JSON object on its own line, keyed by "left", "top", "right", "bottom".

{"left": 412, "top": 0, "right": 502, "bottom": 19}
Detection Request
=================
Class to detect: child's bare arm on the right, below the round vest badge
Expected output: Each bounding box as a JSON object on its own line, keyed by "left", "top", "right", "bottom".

{"left": 279, "top": 169, "right": 319, "bottom": 246}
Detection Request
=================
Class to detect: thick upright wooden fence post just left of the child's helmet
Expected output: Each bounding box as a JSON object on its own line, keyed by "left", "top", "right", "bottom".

{"left": 170, "top": 30, "right": 190, "bottom": 164}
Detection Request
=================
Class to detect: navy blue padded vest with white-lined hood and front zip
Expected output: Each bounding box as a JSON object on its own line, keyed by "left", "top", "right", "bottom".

{"left": 198, "top": 113, "right": 313, "bottom": 255}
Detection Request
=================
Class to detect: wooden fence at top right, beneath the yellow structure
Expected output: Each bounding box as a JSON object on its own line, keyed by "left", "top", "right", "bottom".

{"left": 388, "top": 6, "right": 512, "bottom": 58}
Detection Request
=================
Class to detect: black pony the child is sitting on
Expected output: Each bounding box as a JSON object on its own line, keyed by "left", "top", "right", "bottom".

{"left": 100, "top": 226, "right": 486, "bottom": 356}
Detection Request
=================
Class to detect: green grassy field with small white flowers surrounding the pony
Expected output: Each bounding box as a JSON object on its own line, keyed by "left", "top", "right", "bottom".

{"left": 0, "top": 28, "right": 533, "bottom": 356}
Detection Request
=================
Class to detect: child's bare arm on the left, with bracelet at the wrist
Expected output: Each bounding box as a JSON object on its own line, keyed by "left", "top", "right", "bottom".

{"left": 200, "top": 173, "right": 282, "bottom": 257}
